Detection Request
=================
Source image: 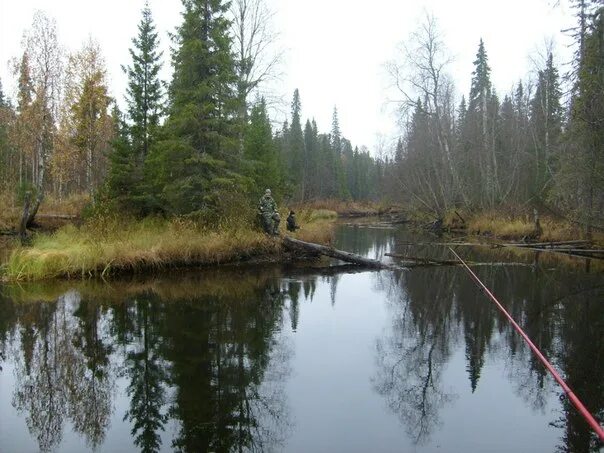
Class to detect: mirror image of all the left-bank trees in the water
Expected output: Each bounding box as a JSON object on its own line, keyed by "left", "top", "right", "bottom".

{"left": 0, "top": 272, "right": 298, "bottom": 452}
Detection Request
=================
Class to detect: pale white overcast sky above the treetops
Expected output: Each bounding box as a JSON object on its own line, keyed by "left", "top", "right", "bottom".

{"left": 0, "top": 0, "right": 574, "bottom": 153}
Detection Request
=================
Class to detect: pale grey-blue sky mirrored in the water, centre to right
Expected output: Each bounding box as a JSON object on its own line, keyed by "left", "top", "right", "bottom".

{"left": 286, "top": 273, "right": 560, "bottom": 452}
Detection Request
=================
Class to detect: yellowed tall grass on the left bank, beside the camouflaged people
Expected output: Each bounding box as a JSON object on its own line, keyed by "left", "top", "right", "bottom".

{"left": 2, "top": 212, "right": 335, "bottom": 281}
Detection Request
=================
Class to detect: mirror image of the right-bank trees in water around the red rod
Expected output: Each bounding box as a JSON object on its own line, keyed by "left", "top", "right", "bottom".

{"left": 373, "top": 267, "right": 604, "bottom": 452}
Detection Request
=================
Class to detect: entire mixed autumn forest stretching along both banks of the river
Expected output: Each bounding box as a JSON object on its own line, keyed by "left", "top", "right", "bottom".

{"left": 0, "top": 0, "right": 604, "bottom": 237}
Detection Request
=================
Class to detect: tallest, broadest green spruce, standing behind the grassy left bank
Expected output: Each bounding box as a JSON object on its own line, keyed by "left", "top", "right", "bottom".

{"left": 147, "top": 0, "right": 245, "bottom": 214}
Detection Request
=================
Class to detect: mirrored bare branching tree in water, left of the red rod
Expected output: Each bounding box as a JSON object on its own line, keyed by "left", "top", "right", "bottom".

{"left": 374, "top": 269, "right": 454, "bottom": 443}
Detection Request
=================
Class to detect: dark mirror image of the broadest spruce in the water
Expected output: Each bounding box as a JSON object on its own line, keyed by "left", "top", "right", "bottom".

{"left": 162, "top": 276, "right": 294, "bottom": 451}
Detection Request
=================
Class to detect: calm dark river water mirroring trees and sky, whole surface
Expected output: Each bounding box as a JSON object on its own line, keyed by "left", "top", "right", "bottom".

{"left": 0, "top": 226, "right": 604, "bottom": 452}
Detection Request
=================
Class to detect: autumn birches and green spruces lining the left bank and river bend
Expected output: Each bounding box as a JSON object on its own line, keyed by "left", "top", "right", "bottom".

{"left": 0, "top": 0, "right": 380, "bottom": 226}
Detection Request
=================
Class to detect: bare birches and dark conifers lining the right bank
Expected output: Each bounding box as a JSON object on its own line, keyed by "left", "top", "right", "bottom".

{"left": 387, "top": 0, "right": 604, "bottom": 230}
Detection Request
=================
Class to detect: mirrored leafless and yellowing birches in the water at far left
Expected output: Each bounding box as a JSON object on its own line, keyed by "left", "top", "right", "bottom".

{"left": 8, "top": 293, "right": 111, "bottom": 451}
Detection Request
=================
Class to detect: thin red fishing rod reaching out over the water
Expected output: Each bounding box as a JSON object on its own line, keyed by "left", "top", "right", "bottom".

{"left": 449, "top": 247, "right": 604, "bottom": 442}
